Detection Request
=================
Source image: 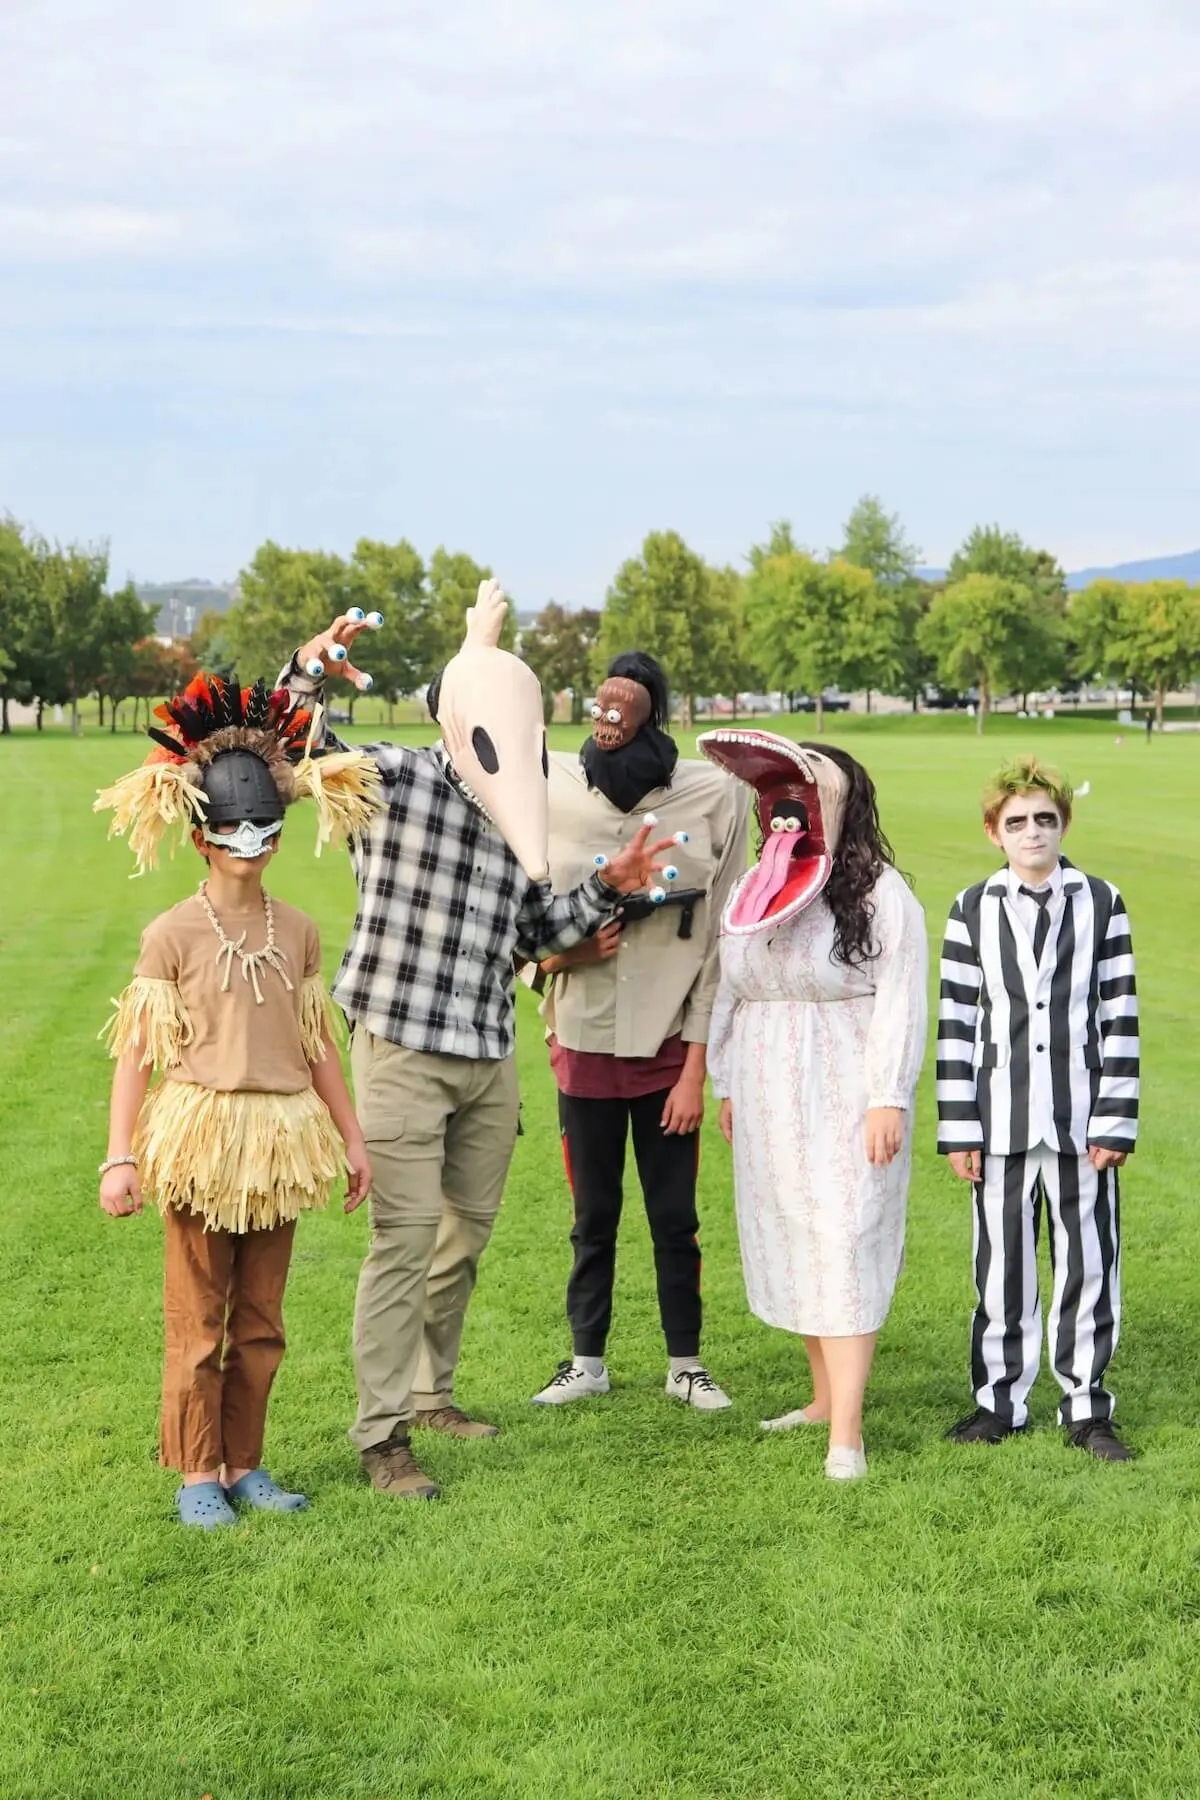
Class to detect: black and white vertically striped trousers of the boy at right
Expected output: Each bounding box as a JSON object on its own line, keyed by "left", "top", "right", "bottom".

{"left": 972, "top": 1145, "right": 1121, "bottom": 1426}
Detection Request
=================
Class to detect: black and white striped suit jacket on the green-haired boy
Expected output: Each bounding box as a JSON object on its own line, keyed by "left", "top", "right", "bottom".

{"left": 937, "top": 857, "right": 1139, "bottom": 1156}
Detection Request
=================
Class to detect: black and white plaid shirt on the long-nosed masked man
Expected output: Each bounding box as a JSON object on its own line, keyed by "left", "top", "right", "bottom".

{"left": 281, "top": 673, "right": 619, "bottom": 1060}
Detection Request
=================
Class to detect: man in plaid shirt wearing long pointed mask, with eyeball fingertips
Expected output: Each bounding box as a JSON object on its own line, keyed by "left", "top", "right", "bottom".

{"left": 281, "top": 583, "right": 664, "bottom": 1499}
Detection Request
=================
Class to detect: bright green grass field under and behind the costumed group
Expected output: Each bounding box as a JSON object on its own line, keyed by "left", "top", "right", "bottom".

{"left": 0, "top": 718, "right": 1200, "bottom": 1800}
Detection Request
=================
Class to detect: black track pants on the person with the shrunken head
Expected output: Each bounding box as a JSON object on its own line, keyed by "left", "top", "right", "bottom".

{"left": 558, "top": 1089, "right": 700, "bottom": 1355}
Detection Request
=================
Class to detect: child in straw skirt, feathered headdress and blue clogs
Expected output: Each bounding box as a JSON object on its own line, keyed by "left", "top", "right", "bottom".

{"left": 95, "top": 675, "right": 378, "bottom": 1528}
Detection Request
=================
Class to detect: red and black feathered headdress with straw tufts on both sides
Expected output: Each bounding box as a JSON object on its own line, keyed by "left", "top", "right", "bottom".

{"left": 92, "top": 675, "right": 381, "bottom": 875}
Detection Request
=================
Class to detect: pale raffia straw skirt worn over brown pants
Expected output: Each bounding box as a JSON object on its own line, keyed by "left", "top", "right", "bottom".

{"left": 133, "top": 1080, "right": 345, "bottom": 1231}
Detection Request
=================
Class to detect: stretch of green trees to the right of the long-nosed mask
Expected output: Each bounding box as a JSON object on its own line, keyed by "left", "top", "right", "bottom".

{"left": 522, "top": 495, "right": 1200, "bottom": 731}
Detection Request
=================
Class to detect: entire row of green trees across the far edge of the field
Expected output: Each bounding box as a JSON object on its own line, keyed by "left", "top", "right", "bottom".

{"left": 0, "top": 495, "right": 1200, "bottom": 731}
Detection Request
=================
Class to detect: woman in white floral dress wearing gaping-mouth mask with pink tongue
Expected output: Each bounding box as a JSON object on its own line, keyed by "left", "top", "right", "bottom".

{"left": 700, "top": 731, "right": 928, "bottom": 1480}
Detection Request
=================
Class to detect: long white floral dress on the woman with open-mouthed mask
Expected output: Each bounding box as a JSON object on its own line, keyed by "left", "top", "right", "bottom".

{"left": 709, "top": 869, "right": 928, "bottom": 1337}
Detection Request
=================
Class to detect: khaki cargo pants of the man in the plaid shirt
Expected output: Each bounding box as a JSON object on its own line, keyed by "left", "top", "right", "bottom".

{"left": 351, "top": 1026, "right": 518, "bottom": 1449}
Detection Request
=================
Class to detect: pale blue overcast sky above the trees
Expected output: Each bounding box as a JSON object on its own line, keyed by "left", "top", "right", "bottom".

{"left": 0, "top": 0, "right": 1200, "bottom": 605}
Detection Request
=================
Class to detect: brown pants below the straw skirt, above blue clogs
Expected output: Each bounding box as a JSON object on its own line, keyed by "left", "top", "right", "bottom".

{"left": 158, "top": 1211, "right": 295, "bottom": 1474}
